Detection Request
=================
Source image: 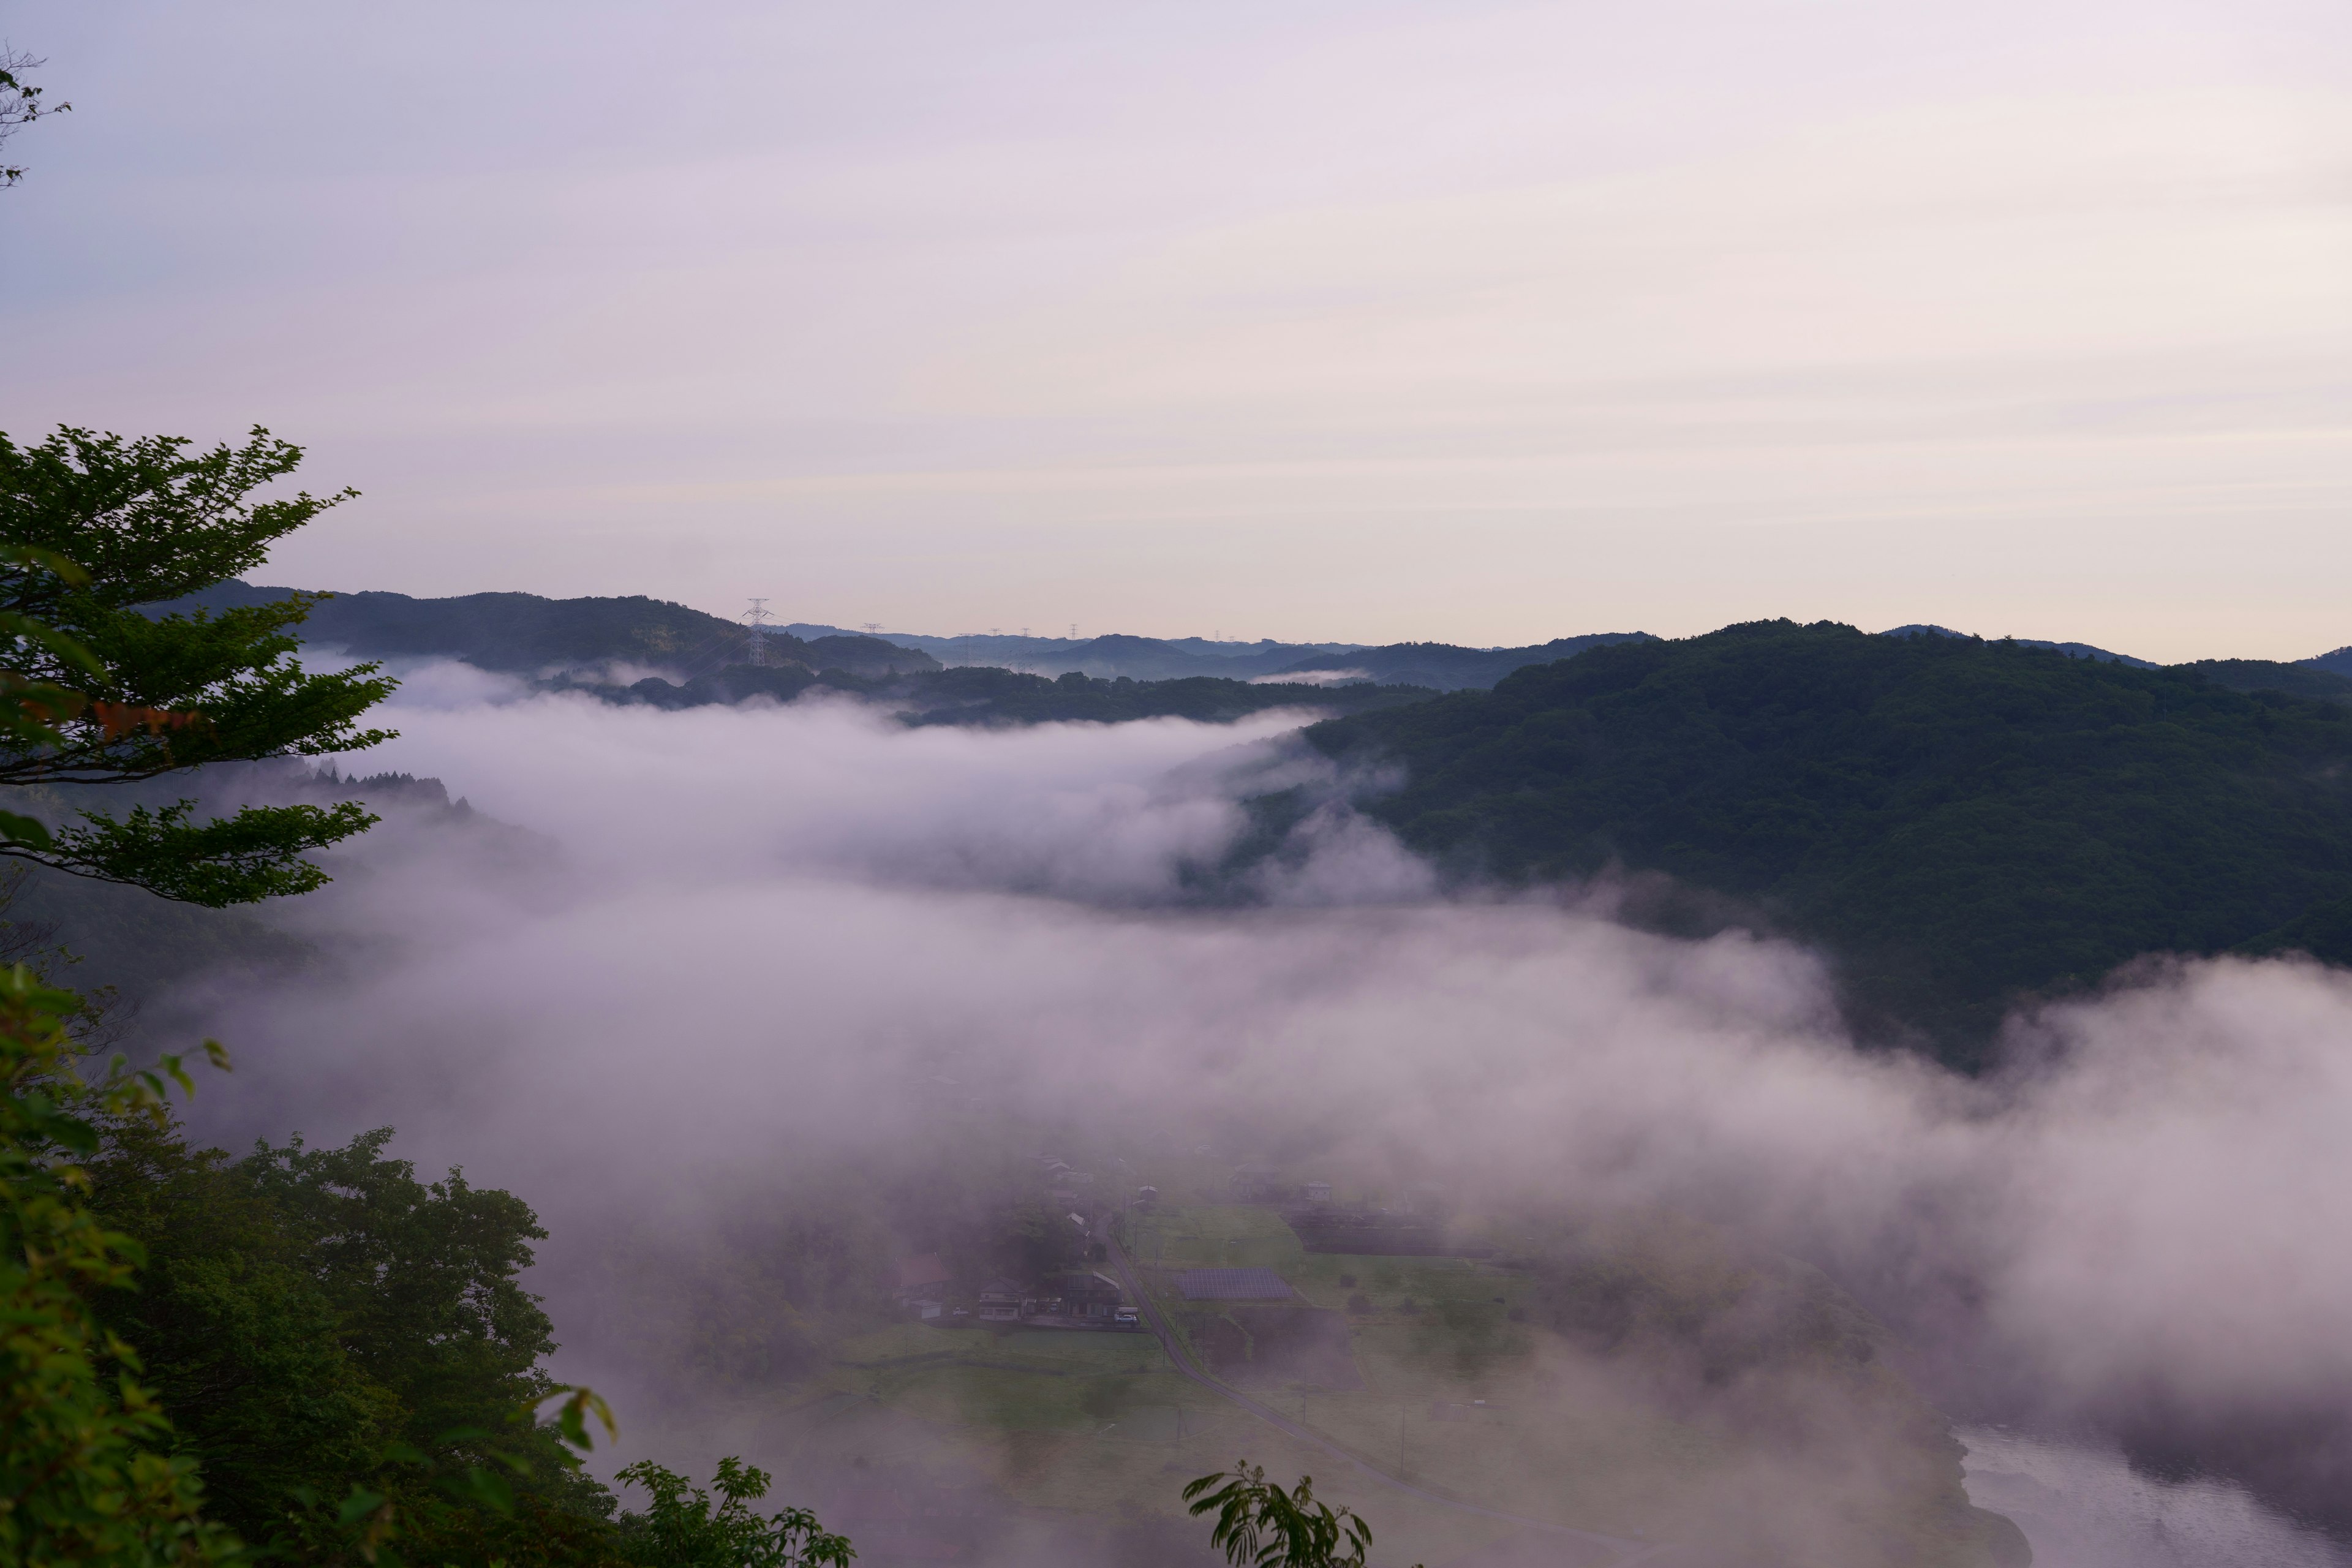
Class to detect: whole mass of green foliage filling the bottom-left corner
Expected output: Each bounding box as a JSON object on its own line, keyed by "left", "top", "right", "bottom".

{"left": 32, "top": 1067, "right": 851, "bottom": 1568}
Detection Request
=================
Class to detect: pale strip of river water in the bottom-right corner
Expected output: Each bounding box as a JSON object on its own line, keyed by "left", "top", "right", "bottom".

{"left": 1959, "top": 1427, "right": 2352, "bottom": 1568}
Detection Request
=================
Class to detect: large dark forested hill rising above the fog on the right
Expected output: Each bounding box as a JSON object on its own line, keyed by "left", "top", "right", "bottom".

{"left": 1308, "top": 620, "right": 2352, "bottom": 1058}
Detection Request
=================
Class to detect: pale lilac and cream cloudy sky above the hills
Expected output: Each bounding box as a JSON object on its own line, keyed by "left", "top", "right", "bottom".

{"left": 0, "top": 0, "right": 2352, "bottom": 661}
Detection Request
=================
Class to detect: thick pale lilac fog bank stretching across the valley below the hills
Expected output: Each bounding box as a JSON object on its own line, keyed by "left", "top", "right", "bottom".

{"left": 186, "top": 677, "right": 2352, "bottom": 1542}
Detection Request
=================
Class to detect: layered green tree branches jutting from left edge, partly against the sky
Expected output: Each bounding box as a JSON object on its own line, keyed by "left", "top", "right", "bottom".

{"left": 0, "top": 428, "right": 393, "bottom": 905}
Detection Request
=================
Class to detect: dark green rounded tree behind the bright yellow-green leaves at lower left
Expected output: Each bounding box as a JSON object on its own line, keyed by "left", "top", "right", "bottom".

{"left": 87, "top": 1117, "right": 609, "bottom": 1540}
